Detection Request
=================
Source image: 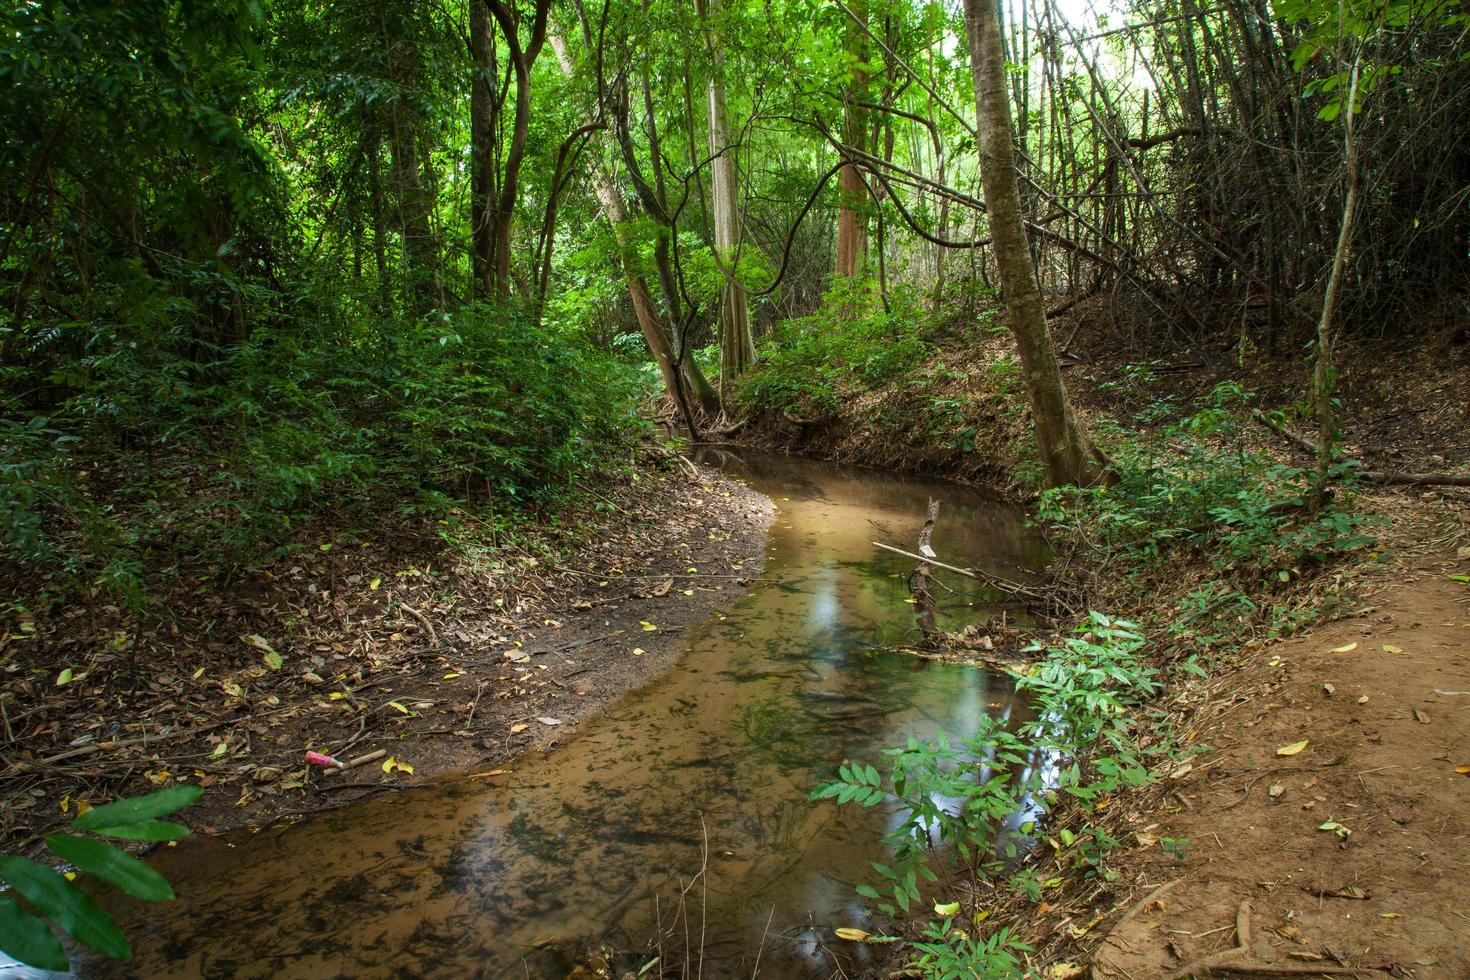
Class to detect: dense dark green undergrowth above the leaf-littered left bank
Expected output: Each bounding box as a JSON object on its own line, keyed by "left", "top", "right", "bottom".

{"left": 0, "top": 306, "right": 644, "bottom": 614}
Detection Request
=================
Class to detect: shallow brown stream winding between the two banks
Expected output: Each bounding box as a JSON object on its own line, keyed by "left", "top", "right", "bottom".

{"left": 82, "top": 453, "right": 1041, "bottom": 977}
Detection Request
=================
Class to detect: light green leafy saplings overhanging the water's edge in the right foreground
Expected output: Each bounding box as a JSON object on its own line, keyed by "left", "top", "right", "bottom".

{"left": 811, "top": 613, "right": 1157, "bottom": 977}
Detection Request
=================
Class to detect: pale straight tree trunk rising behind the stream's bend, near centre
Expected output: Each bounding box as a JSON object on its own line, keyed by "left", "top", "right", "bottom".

{"left": 695, "top": 0, "right": 756, "bottom": 398}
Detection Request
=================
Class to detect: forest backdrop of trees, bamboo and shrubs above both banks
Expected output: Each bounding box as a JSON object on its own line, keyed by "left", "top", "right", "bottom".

{"left": 0, "top": 0, "right": 1470, "bottom": 604}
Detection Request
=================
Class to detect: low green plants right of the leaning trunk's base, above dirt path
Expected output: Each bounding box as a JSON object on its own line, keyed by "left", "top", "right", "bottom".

{"left": 1038, "top": 382, "right": 1372, "bottom": 577}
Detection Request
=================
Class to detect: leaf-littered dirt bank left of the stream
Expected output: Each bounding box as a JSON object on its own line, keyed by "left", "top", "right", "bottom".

{"left": 0, "top": 463, "right": 772, "bottom": 849}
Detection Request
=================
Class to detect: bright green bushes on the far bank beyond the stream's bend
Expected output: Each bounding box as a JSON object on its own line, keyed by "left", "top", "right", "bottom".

{"left": 738, "top": 281, "right": 929, "bottom": 417}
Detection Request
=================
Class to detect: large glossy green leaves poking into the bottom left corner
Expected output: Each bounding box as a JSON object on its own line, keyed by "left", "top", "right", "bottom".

{"left": 0, "top": 786, "right": 204, "bottom": 971}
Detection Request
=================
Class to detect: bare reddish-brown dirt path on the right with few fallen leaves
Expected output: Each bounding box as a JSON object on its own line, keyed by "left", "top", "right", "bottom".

{"left": 1092, "top": 508, "right": 1470, "bottom": 980}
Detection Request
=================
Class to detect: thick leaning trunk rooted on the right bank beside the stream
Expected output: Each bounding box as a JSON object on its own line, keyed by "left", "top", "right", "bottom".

{"left": 964, "top": 0, "right": 1107, "bottom": 486}
